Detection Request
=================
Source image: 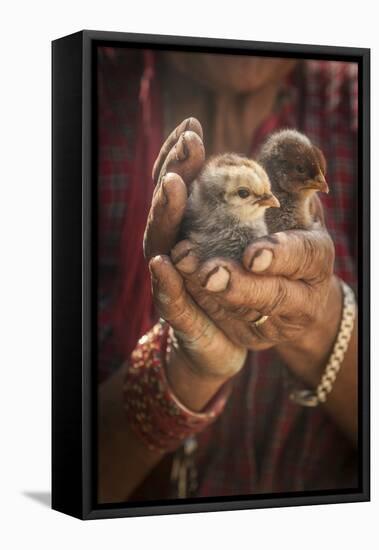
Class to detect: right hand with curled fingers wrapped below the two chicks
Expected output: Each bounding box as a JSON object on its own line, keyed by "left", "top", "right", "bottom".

{"left": 172, "top": 228, "right": 334, "bottom": 350}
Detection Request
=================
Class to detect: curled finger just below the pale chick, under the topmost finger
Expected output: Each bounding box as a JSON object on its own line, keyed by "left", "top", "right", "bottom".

{"left": 199, "top": 258, "right": 321, "bottom": 317}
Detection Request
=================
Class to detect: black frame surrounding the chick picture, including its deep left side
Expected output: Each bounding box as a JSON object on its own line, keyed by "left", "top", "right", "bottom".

{"left": 52, "top": 30, "right": 370, "bottom": 519}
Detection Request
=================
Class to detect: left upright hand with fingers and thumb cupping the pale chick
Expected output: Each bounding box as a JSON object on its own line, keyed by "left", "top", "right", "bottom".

{"left": 144, "top": 119, "right": 246, "bottom": 380}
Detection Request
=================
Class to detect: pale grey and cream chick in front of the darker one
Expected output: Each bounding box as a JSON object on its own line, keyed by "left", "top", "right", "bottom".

{"left": 181, "top": 154, "right": 280, "bottom": 260}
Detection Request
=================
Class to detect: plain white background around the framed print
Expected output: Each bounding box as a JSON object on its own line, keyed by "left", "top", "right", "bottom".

{"left": 0, "top": 0, "right": 379, "bottom": 550}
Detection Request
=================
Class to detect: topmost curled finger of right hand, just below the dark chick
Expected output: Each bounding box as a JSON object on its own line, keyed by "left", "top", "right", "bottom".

{"left": 242, "top": 229, "right": 334, "bottom": 283}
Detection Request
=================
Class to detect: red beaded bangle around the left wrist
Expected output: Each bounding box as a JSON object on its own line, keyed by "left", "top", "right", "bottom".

{"left": 124, "top": 323, "right": 230, "bottom": 452}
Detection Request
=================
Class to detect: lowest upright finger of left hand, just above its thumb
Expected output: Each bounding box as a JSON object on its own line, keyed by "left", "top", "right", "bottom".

{"left": 143, "top": 173, "right": 187, "bottom": 259}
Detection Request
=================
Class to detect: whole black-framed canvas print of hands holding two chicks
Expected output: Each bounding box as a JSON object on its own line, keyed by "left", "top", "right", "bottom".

{"left": 52, "top": 31, "right": 370, "bottom": 519}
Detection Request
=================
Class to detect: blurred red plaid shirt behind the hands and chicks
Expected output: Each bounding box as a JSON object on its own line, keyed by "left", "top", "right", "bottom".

{"left": 98, "top": 48, "right": 357, "bottom": 498}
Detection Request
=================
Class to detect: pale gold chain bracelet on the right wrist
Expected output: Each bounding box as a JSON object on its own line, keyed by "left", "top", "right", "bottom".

{"left": 290, "top": 281, "right": 356, "bottom": 407}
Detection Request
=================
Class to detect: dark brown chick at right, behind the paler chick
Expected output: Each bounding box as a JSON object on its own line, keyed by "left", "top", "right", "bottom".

{"left": 257, "top": 130, "right": 329, "bottom": 233}
